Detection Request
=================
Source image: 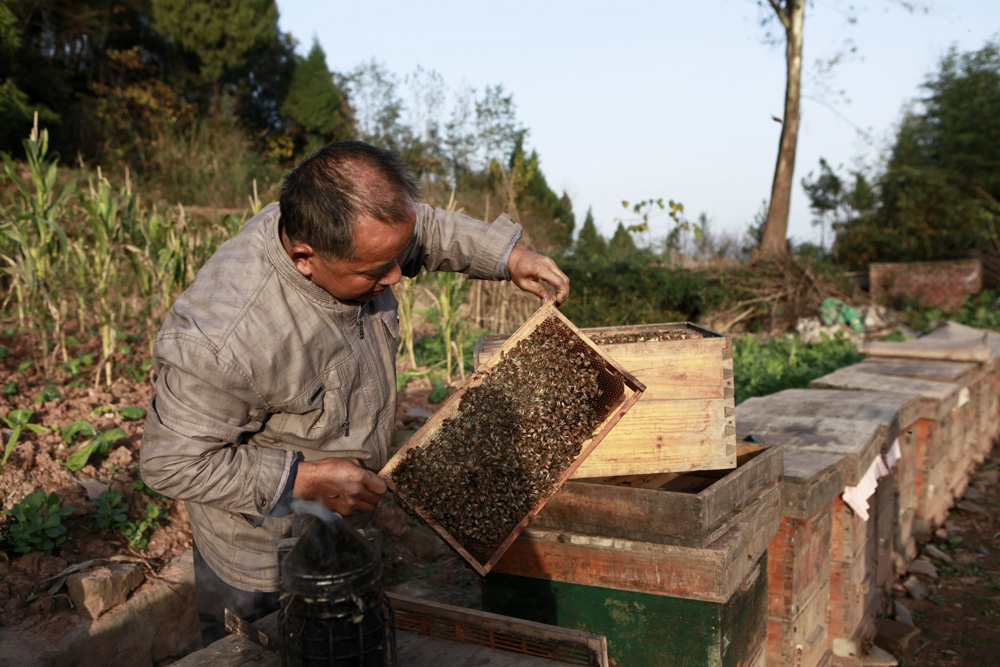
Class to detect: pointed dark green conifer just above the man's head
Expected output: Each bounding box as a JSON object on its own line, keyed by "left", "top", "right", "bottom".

{"left": 281, "top": 41, "right": 354, "bottom": 144}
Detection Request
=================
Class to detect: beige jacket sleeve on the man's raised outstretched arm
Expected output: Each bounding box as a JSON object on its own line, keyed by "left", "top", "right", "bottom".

{"left": 402, "top": 204, "right": 521, "bottom": 280}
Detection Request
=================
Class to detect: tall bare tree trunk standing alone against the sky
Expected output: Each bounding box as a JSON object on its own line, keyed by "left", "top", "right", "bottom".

{"left": 760, "top": 0, "right": 805, "bottom": 257}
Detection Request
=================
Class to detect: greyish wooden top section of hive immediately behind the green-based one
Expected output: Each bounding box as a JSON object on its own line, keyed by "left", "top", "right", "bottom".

{"left": 781, "top": 447, "right": 845, "bottom": 519}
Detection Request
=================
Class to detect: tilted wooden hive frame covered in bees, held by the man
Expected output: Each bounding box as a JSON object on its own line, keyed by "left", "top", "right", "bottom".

{"left": 379, "top": 302, "right": 644, "bottom": 574}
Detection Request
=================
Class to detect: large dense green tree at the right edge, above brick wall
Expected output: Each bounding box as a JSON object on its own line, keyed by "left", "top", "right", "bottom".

{"left": 837, "top": 42, "right": 1000, "bottom": 267}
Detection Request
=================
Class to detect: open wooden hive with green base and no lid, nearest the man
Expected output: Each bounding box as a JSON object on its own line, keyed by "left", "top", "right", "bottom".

{"left": 483, "top": 446, "right": 782, "bottom": 667}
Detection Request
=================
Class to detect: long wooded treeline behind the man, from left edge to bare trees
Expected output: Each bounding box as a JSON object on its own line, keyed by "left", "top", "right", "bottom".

{"left": 0, "top": 0, "right": 574, "bottom": 250}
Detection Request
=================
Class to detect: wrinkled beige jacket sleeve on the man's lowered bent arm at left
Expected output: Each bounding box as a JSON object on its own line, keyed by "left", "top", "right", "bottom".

{"left": 139, "top": 336, "right": 297, "bottom": 525}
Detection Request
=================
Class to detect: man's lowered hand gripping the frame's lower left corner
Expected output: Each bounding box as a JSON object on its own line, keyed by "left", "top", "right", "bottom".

{"left": 292, "top": 458, "right": 386, "bottom": 516}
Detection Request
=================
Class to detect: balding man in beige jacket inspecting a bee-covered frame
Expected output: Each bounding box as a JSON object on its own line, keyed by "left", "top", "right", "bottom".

{"left": 140, "top": 141, "right": 569, "bottom": 644}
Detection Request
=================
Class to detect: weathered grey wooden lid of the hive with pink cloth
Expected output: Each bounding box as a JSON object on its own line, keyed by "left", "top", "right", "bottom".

{"left": 737, "top": 389, "right": 920, "bottom": 452}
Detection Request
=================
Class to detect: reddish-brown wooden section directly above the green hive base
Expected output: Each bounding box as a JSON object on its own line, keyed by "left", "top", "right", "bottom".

{"left": 495, "top": 487, "right": 780, "bottom": 602}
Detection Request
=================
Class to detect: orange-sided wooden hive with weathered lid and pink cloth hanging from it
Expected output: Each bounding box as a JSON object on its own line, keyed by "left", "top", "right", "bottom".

{"left": 736, "top": 389, "right": 916, "bottom": 664}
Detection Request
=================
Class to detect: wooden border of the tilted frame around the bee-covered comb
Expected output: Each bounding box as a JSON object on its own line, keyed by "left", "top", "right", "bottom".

{"left": 379, "top": 300, "right": 646, "bottom": 575}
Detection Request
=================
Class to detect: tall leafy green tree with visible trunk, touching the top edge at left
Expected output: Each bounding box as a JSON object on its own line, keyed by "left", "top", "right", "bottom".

{"left": 151, "top": 0, "right": 278, "bottom": 112}
